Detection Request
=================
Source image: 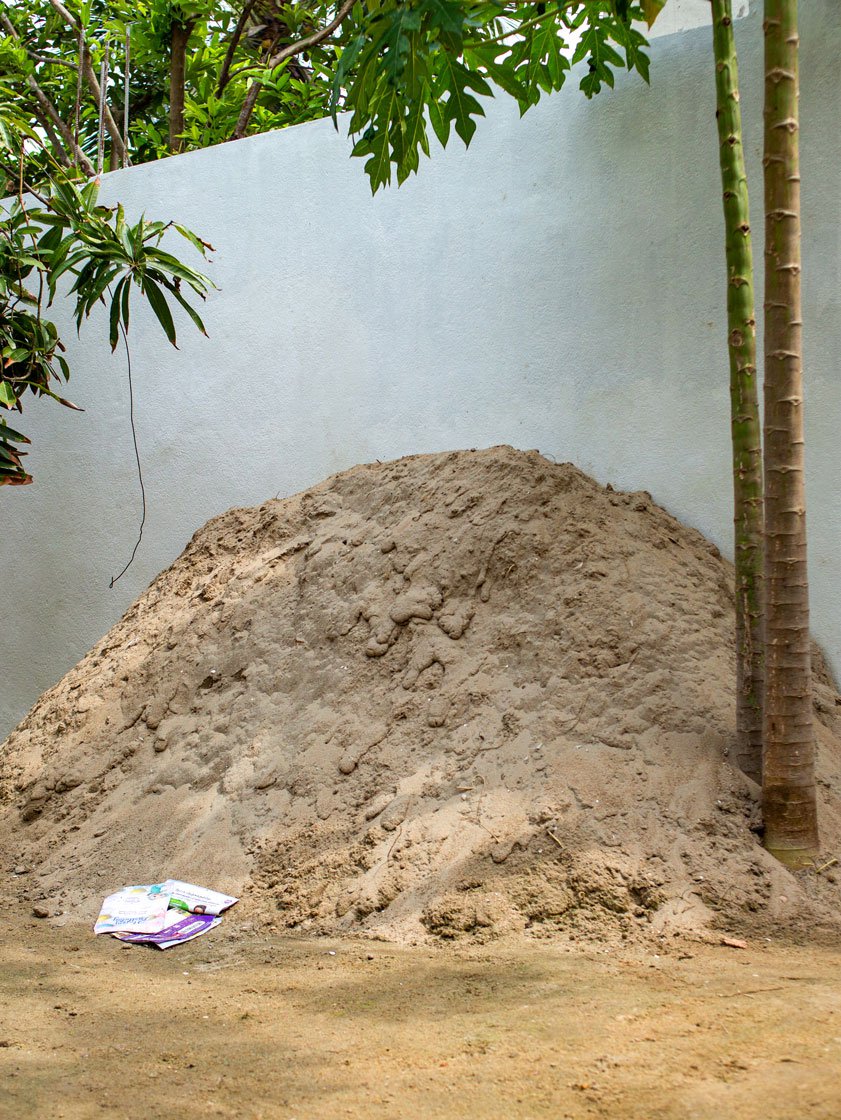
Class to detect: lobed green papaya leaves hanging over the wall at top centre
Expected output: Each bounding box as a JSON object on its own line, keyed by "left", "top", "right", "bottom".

{"left": 331, "top": 0, "right": 648, "bottom": 192}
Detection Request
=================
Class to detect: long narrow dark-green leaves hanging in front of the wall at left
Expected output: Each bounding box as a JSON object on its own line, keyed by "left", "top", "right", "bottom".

{"left": 0, "top": 97, "right": 211, "bottom": 485}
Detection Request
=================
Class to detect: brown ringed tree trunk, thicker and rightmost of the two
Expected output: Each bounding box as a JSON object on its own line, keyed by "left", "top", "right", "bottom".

{"left": 763, "top": 0, "right": 817, "bottom": 867}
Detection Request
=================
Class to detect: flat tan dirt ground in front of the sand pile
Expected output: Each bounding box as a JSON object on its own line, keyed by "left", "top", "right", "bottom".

{"left": 0, "top": 906, "right": 841, "bottom": 1120}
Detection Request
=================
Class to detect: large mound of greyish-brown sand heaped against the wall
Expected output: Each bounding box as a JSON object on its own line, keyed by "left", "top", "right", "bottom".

{"left": 0, "top": 447, "right": 841, "bottom": 940}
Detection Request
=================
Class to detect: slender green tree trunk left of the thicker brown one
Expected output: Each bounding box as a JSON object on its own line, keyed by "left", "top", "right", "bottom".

{"left": 712, "top": 0, "right": 764, "bottom": 783}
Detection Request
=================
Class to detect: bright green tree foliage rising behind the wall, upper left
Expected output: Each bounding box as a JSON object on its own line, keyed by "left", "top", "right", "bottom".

{"left": 0, "top": 0, "right": 347, "bottom": 167}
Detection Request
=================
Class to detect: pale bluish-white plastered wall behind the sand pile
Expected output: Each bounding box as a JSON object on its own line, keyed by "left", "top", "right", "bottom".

{"left": 0, "top": 0, "right": 841, "bottom": 732}
